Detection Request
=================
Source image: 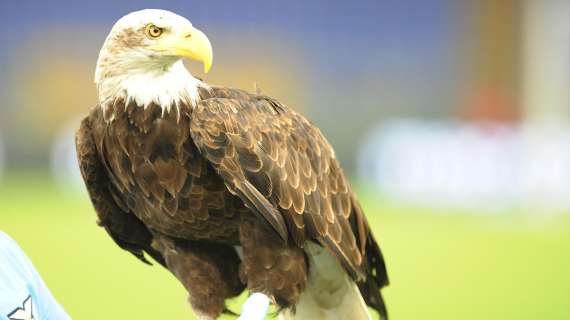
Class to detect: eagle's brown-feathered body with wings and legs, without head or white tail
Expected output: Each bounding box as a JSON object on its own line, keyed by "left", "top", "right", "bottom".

{"left": 77, "top": 87, "right": 388, "bottom": 315}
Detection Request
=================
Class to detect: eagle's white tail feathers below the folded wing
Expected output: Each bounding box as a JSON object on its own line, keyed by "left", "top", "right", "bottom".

{"left": 280, "top": 243, "right": 372, "bottom": 320}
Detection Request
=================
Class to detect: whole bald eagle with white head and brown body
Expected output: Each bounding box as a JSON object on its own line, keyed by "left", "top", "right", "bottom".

{"left": 76, "top": 10, "right": 388, "bottom": 319}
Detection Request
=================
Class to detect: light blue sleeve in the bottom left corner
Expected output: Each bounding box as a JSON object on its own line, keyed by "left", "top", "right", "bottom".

{"left": 0, "top": 231, "right": 71, "bottom": 320}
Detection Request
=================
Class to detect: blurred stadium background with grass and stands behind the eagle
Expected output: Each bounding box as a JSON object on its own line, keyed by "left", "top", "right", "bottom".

{"left": 0, "top": 0, "right": 570, "bottom": 320}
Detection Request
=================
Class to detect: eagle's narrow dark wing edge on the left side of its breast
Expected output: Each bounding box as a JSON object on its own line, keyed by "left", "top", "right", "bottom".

{"left": 75, "top": 118, "right": 165, "bottom": 265}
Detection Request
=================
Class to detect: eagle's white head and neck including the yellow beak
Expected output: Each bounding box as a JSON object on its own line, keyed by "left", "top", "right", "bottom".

{"left": 95, "top": 9, "right": 212, "bottom": 110}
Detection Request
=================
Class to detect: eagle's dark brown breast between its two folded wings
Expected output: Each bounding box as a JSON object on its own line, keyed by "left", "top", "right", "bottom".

{"left": 90, "top": 100, "right": 249, "bottom": 244}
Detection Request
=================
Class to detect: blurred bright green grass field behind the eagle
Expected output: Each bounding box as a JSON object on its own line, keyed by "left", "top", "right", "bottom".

{"left": 0, "top": 174, "right": 570, "bottom": 320}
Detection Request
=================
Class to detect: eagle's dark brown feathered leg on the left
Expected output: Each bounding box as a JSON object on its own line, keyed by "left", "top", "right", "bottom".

{"left": 152, "top": 235, "right": 245, "bottom": 320}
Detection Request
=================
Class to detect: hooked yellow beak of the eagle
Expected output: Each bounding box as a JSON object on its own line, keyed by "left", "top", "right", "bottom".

{"left": 170, "top": 28, "right": 213, "bottom": 73}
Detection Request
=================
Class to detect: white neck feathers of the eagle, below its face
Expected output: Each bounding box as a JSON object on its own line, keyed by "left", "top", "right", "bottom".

{"left": 95, "top": 60, "right": 207, "bottom": 114}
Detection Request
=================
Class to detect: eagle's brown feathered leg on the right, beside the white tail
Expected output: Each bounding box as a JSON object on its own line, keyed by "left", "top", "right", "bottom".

{"left": 240, "top": 220, "right": 307, "bottom": 308}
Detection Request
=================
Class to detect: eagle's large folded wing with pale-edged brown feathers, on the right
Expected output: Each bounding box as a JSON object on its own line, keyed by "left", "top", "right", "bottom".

{"left": 190, "top": 95, "right": 369, "bottom": 278}
